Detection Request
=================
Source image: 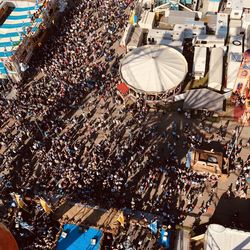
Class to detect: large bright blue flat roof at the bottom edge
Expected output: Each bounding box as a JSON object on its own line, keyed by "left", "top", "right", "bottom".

{"left": 56, "top": 224, "right": 102, "bottom": 250}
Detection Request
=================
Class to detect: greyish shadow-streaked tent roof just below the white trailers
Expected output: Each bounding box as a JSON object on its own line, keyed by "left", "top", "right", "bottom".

{"left": 183, "top": 89, "right": 224, "bottom": 112}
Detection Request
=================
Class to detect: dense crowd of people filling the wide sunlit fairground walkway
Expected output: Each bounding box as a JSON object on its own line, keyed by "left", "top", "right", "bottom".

{"left": 0, "top": 0, "right": 249, "bottom": 249}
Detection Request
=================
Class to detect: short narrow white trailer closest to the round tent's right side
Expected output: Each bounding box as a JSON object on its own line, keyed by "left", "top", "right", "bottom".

{"left": 193, "top": 47, "right": 207, "bottom": 80}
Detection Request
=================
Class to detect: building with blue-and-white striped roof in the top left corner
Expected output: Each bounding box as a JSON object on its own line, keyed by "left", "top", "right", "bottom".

{"left": 0, "top": 0, "right": 60, "bottom": 82}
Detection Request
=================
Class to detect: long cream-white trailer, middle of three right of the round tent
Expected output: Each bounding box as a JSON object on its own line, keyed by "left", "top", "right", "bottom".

{"left": 208, "top": 48, "right": 224, "bottom": 91}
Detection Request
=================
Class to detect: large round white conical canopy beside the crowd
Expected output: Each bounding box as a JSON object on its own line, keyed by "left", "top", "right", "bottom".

{"left": 120, "top": 45, "right": 188, "bottom": 93}
